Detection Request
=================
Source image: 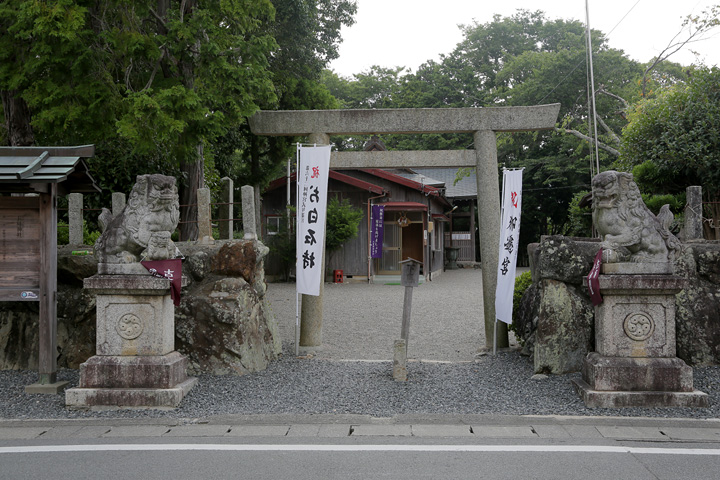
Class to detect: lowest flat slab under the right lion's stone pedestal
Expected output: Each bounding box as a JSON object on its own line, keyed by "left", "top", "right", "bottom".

{"left": 573, "top": 379, "right": 708, "bottom": 408}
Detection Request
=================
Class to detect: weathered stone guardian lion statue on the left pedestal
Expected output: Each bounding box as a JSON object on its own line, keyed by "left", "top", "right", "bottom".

{"left": 95, "top": 174, "right": 180, "bottom": 263}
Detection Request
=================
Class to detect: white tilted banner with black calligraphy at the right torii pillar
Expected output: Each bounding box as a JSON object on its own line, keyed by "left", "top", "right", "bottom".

{"left": 495, "top": 170, "right": 522, "bottom": 324}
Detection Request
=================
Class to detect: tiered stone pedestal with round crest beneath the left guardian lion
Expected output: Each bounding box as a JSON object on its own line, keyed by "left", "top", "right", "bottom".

{"left": 65, "top": 269, "right": 197, "bottom": 408}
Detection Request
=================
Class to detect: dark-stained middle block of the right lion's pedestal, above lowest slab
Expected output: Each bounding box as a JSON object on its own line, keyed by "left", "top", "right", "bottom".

{"left": 582, "top": 352, "right": 694, "bottom": 392}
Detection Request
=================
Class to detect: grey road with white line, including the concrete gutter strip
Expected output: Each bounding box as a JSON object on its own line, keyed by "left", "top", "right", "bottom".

{"left": 0, "top": 415, "right": 720, "bottom": 480}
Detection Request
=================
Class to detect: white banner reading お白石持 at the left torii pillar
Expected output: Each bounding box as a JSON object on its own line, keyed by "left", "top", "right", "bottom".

{"left": 296, "top": 145, "right": 330, "bottom": 296}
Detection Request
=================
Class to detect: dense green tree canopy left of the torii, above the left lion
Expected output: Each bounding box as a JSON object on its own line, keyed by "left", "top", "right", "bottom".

{"left": 0, "top": 0, "right": 355, "bottom": 239}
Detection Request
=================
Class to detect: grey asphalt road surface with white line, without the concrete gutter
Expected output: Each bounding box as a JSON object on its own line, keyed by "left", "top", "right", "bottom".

{"left": 0, "top": 438, "right": 720, "bottom": 480}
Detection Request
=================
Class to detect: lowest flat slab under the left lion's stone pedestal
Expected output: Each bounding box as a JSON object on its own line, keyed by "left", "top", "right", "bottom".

{"left": 65, "top": 377, "right": 197, "bottom": 408}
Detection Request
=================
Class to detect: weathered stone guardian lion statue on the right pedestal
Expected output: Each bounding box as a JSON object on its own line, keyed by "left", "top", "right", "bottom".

{"left": 592, "top": 170, "right": 681, "bottom": 263}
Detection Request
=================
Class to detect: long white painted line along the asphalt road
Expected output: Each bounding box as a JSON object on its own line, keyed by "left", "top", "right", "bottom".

{"left": 0, "top": 443, "right": 720, "bottom": 456}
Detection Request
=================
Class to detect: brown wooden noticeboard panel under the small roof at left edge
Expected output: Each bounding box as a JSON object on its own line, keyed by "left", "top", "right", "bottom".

{"left": 0, "top": 197, "right": 42, "bottom": 301}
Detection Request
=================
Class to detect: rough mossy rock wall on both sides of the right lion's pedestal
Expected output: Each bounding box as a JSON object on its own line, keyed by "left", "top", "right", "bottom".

{"left": 517, "top": 236, "right": 720, "bottom": 374}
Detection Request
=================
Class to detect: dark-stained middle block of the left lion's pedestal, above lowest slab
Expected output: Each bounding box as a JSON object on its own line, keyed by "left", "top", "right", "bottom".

{"left": 79, "top": 352, "right": 187, "bottom": 389}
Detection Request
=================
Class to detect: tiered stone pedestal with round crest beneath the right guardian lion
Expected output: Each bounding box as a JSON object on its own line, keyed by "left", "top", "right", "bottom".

{"left": 573, "top": 264, "right": 708, "bottom": 408}
